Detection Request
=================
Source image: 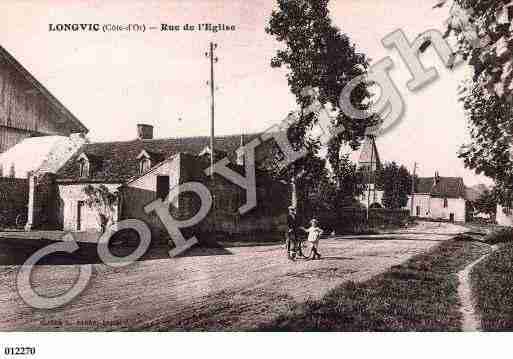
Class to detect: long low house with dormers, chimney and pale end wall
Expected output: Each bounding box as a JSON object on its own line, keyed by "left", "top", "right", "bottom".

{"left": 29, "top": 124, "right": 289, "bottom": 238}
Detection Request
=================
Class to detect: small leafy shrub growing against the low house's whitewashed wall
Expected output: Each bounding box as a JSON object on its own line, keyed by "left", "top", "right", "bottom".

{"left": 83, "top": 184, "right": 119, "bottom": 233}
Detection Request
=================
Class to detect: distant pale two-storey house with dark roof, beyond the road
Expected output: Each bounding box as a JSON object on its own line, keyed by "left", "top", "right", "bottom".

{"left": 407, "top": 172, "right": 467, "bottom": 222}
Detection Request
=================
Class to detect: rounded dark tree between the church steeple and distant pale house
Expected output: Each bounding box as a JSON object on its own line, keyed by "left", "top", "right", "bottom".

{"left": 376, "top": 162, "right": 411, "bottom": 209}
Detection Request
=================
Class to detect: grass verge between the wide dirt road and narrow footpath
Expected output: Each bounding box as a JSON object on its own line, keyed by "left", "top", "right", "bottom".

{"left": 259, "top": 240, "right": 488, "bottom": 331}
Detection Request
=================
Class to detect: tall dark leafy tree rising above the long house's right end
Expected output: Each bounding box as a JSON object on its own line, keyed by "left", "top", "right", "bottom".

{"left": 266, "top": 0, "right": 372, "bottom": 208}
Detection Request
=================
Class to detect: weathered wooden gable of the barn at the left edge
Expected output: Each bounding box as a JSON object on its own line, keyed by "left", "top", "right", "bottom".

{"left": 0, "top": 46, "right": 88, "bottom": 153}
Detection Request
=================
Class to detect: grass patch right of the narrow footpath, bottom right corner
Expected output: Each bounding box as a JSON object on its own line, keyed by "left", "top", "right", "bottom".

{"left": 470, "top": 243, "right": 513, "bottom": 331}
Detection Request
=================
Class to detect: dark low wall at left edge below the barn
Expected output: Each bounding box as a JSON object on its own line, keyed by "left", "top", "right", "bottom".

{"left": 0, "top": 177, "right": 29, "bottom": 228}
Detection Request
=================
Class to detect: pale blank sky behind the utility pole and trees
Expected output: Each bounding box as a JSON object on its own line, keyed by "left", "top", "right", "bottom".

{"left": 0, "top": 0, "right": 491, "bottom": 186}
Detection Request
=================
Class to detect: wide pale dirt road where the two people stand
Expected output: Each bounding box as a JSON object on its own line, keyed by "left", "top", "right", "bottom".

{"left": 0, "top": 223, "right": 464, "bottom": 331}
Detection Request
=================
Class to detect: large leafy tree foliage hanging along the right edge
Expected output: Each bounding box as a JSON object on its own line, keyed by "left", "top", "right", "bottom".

{"left": 435, "top": 0, "right": 513, "bottom": 205}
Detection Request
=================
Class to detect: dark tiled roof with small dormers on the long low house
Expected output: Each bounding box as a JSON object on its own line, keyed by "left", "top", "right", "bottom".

{"left": 57, "top": 134, "right": 272, "bottom": 183}
